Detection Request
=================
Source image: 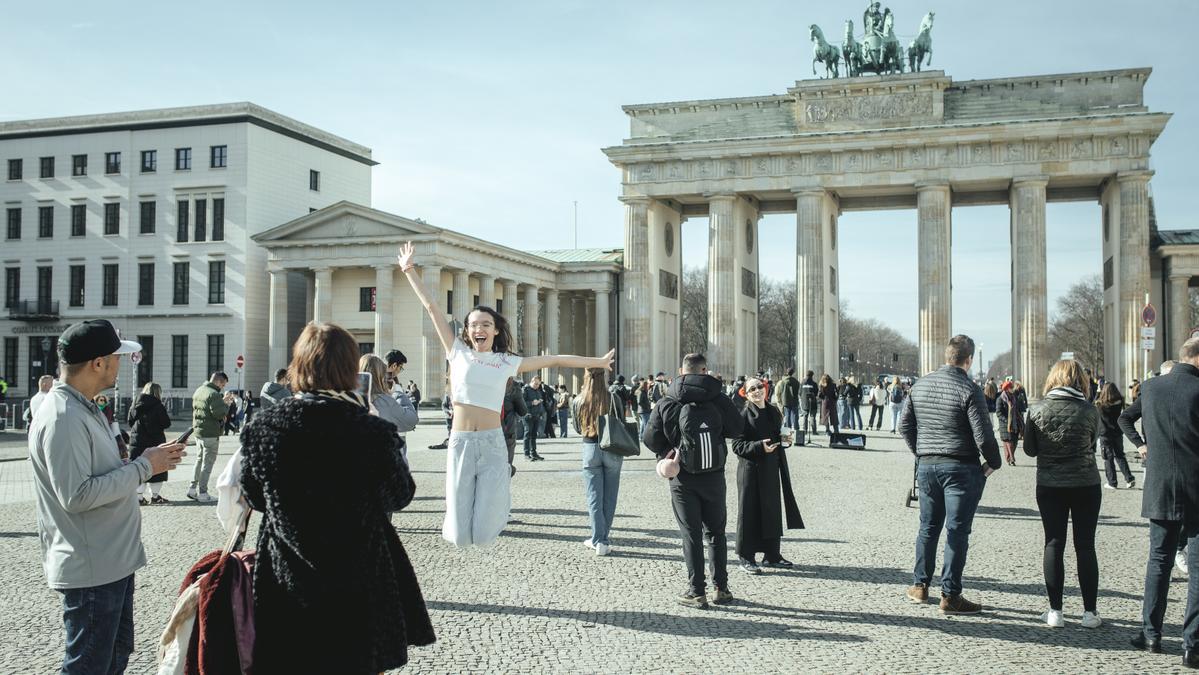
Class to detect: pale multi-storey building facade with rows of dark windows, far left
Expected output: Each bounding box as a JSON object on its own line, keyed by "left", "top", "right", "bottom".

{"left": 0, "top": 103, "right": 374, "bottom": 398}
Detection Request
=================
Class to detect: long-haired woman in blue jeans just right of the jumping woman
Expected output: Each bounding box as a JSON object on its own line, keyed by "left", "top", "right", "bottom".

{"left": 571, "top": 368, "right": 625, "bottom": 555}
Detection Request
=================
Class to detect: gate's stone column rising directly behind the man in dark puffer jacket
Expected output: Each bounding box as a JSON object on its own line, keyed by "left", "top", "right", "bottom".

{"left": 916, "top": 183, "right": 952, "bottom": 375}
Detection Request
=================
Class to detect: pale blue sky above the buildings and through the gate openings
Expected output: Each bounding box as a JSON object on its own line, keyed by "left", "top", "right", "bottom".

{"left": 0, "top": 0, "right": 1199, "bottom": 369}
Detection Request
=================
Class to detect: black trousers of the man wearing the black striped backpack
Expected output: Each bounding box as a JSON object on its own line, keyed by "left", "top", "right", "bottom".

{"left": 670, "top": 471, "right": 729, "bottom": 593}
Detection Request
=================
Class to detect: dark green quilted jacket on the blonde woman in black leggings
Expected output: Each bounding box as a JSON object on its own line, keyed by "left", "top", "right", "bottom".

{"left": 1024, "top": 387, "right": 1099, "bottom": 488}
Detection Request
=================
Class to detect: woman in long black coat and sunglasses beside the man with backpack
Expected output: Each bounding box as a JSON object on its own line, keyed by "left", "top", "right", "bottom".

{"left": 733, "top": 378, "right": 803, "bottom": 574}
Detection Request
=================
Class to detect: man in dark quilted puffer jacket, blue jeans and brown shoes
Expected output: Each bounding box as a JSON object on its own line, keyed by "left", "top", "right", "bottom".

{"left": 899, "top": 336, "right": 1002, "bottom": 614}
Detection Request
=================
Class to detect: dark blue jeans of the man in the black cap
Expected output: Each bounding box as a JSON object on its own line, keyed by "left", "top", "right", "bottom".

{"left": 59, "top": 574, "right": 133, "bottom": 675}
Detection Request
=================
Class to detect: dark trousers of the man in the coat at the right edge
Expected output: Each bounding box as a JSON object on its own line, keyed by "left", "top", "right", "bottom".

{"left": 1141, "top": 520, "right": 1199, "bottom": 650}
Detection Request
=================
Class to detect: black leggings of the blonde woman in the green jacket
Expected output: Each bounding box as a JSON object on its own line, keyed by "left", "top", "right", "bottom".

{"left": 1037, "top": 483, "right": 1102, "bottom": 611}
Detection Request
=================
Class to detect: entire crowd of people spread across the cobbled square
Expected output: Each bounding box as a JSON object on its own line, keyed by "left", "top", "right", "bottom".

{"left": 16, "top": 236, "right": 1199, "bottom": 673}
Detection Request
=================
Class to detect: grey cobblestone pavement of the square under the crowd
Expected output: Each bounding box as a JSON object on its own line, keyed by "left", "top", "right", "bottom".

{"left": 0, "top": 414, "right": 1186, "bottom": 673}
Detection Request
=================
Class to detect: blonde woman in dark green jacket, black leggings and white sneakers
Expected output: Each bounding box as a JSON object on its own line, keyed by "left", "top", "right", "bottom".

{"left": 1024, "top": 360, "right": 1103, "bottom": 628}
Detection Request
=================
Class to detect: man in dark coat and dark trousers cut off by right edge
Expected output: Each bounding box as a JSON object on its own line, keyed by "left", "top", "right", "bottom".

{"left": 1120, "top": 338, "right": 1199, "bottom": 668}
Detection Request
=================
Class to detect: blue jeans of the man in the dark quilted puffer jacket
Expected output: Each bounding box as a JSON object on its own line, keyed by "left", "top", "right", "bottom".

{"left": 912, "top": 460, "right": 987, "bottom": 596}
